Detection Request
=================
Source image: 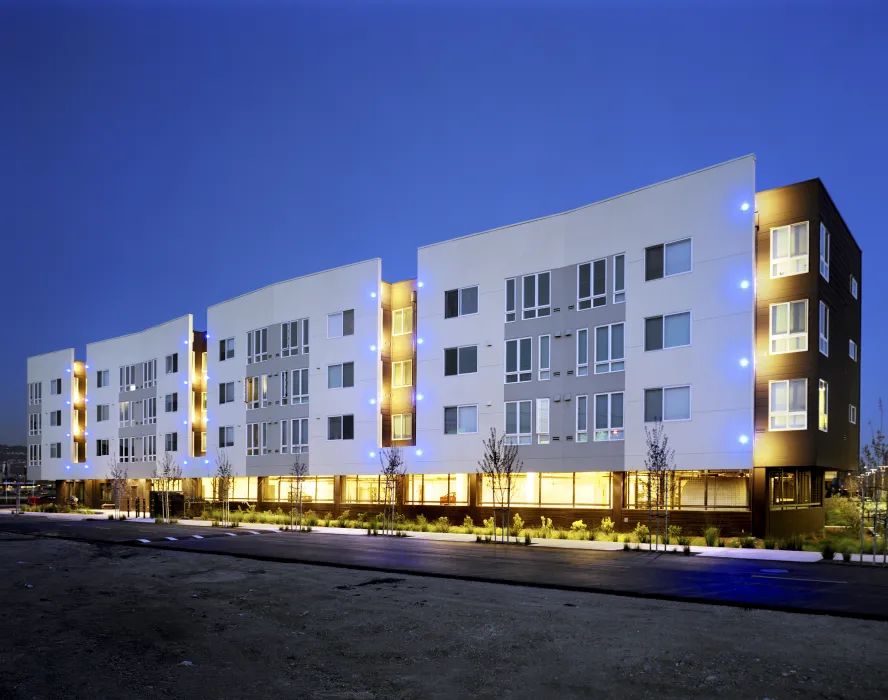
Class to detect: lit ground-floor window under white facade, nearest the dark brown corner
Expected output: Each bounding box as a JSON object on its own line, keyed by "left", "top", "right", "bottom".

{"left": 623, "top": 470, "right": 750, "bottom": 510}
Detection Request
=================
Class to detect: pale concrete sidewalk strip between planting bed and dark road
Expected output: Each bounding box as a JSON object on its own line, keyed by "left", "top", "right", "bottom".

{"left": 0, "top": 511, "right": 882, "bottom": 565}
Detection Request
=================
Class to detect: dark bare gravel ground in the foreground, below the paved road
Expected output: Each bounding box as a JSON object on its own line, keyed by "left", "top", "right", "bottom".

{"left": 0, "top": 534, "right": 888, "bottom": 700}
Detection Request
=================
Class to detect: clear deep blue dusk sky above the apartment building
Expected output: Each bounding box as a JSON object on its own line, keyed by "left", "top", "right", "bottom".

{"left": 0, "top": 0, "right": 888, "bottom": 442}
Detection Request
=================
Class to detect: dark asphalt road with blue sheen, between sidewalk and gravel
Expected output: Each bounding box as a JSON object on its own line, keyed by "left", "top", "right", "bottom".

{"left": 0, "top": 516, "right": 888, "bottom": 621}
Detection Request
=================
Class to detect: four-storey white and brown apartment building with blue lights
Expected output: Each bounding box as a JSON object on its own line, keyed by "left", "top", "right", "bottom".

{"left": 28, "top": 156, "right": 861, "bottom": 535}
